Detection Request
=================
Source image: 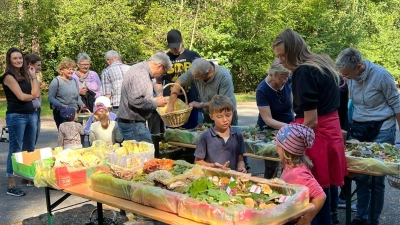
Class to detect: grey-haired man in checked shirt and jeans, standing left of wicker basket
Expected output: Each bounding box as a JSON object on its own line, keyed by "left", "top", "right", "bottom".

{"left": 117, "top": 52, "right": 172, "bottom": 143}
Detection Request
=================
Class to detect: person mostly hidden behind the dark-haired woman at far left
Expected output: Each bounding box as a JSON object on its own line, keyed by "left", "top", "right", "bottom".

{"left": 25, "top": 53, "right": 42, "bottom": 145}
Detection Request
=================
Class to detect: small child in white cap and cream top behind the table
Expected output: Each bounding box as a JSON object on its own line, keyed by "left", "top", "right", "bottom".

{"left": 89, "top": 105, "right": 123, "bottom": 144}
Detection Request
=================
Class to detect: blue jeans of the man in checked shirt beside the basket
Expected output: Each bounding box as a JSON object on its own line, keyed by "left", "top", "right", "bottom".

{"left": 118, "top": 122, "right": 153, "bottom": 143}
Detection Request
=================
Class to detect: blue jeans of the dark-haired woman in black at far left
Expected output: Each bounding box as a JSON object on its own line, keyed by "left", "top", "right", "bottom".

{"left": 6, "top": 112, "right": 37, "bottom": 177}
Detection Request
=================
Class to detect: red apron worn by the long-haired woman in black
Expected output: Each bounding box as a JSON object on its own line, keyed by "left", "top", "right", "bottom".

{"left": 293, "top": 111, "right": 348, "bottom": 188}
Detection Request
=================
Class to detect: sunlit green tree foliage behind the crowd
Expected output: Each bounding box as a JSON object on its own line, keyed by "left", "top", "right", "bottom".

{"left": 0, "top": 0, "right": 400, "bottom": 92}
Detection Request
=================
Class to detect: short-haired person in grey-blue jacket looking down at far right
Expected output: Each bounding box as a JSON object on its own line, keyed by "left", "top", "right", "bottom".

{"left": 336, "top": 48, "right": 400, "bottom": 225}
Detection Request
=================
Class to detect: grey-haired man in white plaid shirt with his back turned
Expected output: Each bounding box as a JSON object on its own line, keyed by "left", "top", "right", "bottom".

{"left": 101, "top": 50, "right": 130, "bottom": 113}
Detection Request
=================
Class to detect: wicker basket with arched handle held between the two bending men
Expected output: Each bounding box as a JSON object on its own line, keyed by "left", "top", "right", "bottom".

{"left": 157, "top": 83, "right": 193, "bottom": 127}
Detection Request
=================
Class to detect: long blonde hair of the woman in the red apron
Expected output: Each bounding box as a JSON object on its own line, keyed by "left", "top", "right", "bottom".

{"left": 272, "top": 29, "right": 340, "bottom": 85}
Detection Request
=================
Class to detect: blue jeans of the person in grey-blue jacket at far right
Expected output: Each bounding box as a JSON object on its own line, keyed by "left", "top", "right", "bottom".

{"left": 353, "top": 125, "right": 396, "bottom": 224}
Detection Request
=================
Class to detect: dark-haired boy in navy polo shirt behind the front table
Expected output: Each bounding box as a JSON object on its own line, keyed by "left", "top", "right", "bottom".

{"left": 194, "top": 95, "right": 246, "bottom": 173}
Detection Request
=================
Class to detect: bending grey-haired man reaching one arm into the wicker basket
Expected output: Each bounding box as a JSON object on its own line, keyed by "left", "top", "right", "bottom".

{"left": 166, "top": 58, "right": 238, "bottom": 125}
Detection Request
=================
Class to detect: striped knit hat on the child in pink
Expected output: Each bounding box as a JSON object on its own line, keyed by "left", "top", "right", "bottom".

{"left": 275, "top": 123, "right": 315, "bottom": 155}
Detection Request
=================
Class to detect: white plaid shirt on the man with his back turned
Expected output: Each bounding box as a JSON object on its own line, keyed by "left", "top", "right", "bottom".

{"left": 101, "top": 61, "right": 130, "bottom": 106}
